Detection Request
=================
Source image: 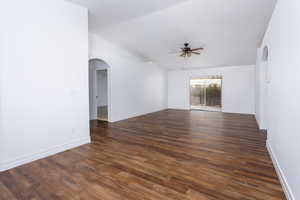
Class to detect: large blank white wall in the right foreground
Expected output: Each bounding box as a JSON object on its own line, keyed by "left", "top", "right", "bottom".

{"left": 255, "top": 0, "right": 300, "bottom": 199}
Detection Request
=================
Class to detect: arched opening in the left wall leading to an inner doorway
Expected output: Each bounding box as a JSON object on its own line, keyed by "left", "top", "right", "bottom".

{"left": 89, "top": 58, "right": 111, "bottom": 121}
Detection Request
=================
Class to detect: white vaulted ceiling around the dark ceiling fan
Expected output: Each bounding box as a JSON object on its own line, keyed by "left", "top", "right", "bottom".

{"left": 70, "top": 0, "right": 276, "bottom": 69}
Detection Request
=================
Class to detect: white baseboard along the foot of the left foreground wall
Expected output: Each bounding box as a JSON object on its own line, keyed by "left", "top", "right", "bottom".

{"left": 0, "top": 137, "right": 91, "bottom": 172}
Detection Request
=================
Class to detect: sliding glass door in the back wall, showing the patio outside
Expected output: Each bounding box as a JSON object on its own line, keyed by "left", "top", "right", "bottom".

{"left": 190, "top": 76, "right": 222, "bottom": 112}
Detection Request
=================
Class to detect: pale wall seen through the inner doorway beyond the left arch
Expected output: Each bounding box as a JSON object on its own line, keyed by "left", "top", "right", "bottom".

{"left": 97, "top": 70, "right": 108, "bottom": 107}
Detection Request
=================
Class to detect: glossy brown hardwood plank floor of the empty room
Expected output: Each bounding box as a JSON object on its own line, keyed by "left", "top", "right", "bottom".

{"left": 0, "top": 110, "right": 285, "bottom": 200}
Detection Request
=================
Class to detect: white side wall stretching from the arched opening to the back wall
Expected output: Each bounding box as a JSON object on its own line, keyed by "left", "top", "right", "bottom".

{"left": 90, "top": 33, "right": 167, "bottom": 121}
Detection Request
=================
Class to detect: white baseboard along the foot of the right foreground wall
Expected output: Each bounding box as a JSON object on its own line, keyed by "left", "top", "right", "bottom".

{"left": 267, "top": 141, "right": 296, "bottom": 200}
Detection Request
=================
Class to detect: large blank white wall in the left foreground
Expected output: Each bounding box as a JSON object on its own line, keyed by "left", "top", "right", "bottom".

{"left": 0, "top": 0, "right": 90, "bottom": 171}
